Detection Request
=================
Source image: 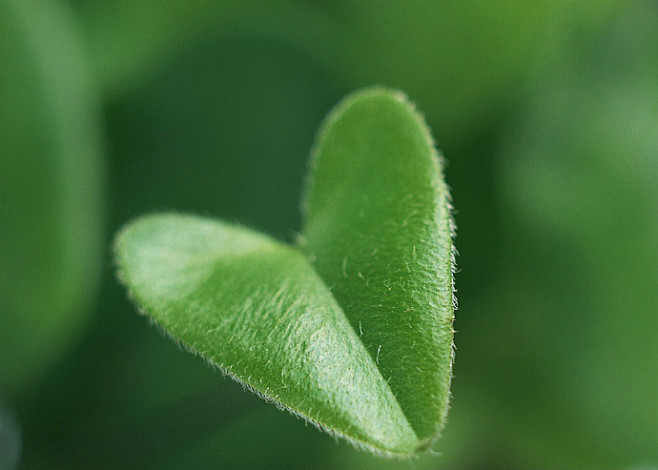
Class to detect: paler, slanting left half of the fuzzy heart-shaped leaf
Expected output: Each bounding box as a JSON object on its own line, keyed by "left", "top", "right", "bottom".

{"left": 116, "top": 215, "right": 418, "bottom": 454}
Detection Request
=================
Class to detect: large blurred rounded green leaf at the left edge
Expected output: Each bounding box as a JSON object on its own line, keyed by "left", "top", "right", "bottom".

{"left": 0, "top": 0, "right": 103, "bottom": 393}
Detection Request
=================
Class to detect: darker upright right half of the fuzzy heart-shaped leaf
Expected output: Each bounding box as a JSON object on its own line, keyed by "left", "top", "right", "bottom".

{"left": 303, "top": 89, "right": 453, "bottom": 448}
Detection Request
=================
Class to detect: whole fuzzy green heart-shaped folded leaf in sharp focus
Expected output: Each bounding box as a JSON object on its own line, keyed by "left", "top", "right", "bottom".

{"left": 116, "top": 88, "right": 453, "bottom": 456}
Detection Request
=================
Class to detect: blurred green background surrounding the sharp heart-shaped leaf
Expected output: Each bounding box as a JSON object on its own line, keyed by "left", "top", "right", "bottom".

{"left": 0, "top": 0, "right": 658, "bottom": 470}
